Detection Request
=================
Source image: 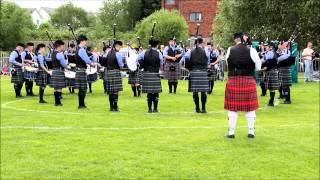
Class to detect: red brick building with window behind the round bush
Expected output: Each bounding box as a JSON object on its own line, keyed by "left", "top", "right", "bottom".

{"left": 161, "top": 0, "right": 218, "bottom": 40}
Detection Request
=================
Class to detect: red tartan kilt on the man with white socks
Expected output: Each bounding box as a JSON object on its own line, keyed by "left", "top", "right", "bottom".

{"left": 224, "top": 76, "right": 259, "bottom": 112}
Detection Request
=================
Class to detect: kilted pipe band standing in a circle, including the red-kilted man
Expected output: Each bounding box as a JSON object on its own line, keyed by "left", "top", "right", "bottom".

{"left": 9, "top": 24, "right": 318, "bottom": 138}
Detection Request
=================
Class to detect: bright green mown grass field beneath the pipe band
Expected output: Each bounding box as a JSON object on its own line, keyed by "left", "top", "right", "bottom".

{"left": 1, "top": 74, "right": 319, "bottom": 179}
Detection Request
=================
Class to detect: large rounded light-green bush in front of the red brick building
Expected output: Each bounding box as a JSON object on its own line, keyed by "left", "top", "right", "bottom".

{"left": 136, "top": 9, "right": 188, "bottom": 45}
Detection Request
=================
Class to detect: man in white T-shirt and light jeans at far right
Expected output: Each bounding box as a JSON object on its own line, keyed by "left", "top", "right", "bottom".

{"left": 302, "top": 41, "right": 314, "bottom": 82}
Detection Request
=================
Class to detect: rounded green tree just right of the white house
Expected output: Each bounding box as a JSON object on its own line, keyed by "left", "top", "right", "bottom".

{"left": 51, "top": 3, "right": 89, "bottom": 29}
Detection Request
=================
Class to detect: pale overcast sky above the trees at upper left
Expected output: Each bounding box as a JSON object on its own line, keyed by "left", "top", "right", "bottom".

{"left": 5, "top": 0, "right": 104, "bottom": 12}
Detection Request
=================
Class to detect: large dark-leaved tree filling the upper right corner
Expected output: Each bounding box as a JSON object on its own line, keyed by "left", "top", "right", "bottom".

{"left": 213, "top": 0, "right": 320, "bottom": 47}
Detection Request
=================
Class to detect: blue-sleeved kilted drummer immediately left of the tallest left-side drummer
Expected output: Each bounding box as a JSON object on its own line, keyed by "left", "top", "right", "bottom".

{"left": 50, "top": 40, "right": 69, "bottom": 106}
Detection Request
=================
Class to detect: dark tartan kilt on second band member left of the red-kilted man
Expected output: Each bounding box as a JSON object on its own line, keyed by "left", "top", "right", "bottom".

{"left": 142, "top": 71, "right": 162, "bottom": 93}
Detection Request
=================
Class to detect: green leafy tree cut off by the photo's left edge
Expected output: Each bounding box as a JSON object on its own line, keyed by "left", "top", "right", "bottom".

{"left": 0, "top": 2, "right": 34, "bottom": 50}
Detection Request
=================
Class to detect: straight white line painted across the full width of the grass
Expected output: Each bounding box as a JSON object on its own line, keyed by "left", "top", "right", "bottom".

{"left": 0, "top": 123, "right": 319, "bottom": 131}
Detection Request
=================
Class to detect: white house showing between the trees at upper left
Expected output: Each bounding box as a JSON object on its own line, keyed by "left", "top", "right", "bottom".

{"left": 29, "top": 7, "right": 55, "bottom": 27}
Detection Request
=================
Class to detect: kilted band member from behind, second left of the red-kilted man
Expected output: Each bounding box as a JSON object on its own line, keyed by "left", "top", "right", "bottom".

{"left": 138, "top": 39, "right": 163, "bottom": 113}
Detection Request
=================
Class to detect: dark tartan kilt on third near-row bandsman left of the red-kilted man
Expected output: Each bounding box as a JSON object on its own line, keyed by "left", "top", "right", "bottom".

{"left": 104, "top": 69, "right": 123, "bottom": 94}
